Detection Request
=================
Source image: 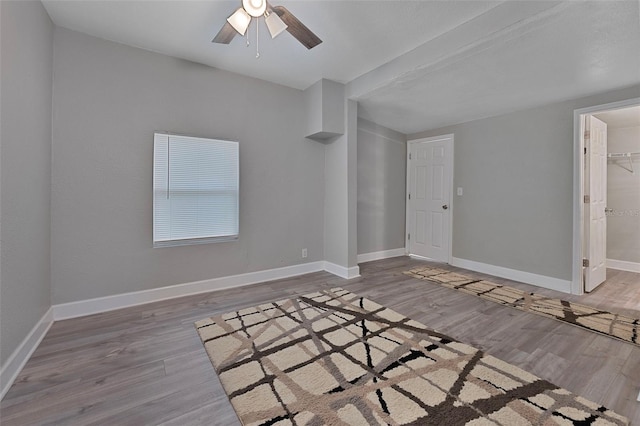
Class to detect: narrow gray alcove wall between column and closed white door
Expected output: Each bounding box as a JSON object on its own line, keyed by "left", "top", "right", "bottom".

{"left": 358, "top": 118, "right": 407, "bottom": 254}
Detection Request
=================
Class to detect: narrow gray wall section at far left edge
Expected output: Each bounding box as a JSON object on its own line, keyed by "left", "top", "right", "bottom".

{"left": 0, "top": 1, "right": 53, "bottom": 366}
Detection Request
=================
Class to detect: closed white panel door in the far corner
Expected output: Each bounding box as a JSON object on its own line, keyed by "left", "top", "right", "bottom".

{"left": 407, "top": 137, "right": 453, "bottom": 262}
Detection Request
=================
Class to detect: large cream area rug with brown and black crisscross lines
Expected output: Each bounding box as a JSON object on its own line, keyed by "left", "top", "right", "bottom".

{"left": 196, "top": 288, "right": 628, "bottom": 426}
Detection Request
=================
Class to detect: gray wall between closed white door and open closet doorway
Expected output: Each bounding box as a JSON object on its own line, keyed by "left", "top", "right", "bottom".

{"left": 408, "top": 86, "right": 640, "bottom": 280}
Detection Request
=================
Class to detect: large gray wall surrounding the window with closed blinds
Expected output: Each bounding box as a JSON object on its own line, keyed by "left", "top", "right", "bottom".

{"left": 52, "top": 28, "right": 325, "bottom": 304}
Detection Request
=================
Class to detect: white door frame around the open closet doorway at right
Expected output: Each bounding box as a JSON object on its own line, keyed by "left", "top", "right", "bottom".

{"left": 571, "top": 98, "right": 640, "bottom": 294}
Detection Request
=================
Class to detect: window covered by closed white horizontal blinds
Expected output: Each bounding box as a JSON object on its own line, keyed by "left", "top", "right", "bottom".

{"left": 153, "top": 133, "right": 239, "bottom": 247}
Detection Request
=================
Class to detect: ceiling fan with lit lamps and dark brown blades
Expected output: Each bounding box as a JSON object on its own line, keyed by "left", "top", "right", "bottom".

{"left": 212, "top": 0, "right": 322, "bottom": 49}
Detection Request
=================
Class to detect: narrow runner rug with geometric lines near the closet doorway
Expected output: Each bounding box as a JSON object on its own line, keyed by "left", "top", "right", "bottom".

{"left": 405, "top": 266, "right": 640, "bottom": 345}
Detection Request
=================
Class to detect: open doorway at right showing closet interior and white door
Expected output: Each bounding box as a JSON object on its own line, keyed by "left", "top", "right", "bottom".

{"left": 572, "top": 98, "right": 640, "bottom": 294}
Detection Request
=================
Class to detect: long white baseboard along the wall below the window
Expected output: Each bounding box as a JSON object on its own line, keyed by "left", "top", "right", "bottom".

{"left": 53, "top": 261, "right": 324, "bottom": 321}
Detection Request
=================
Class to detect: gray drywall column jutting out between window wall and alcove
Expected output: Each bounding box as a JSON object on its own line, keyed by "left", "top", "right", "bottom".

{"left": 324, "top": 99, "right": 359, "bottom": 278}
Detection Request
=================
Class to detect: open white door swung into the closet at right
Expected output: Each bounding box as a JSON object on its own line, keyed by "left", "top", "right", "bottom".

{"left": 584, "top": 116, "right": 607, "bottom": 291}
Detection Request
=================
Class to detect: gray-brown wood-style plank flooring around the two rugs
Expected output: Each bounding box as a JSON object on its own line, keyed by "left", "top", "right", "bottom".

{"left": 0, "top": 257, "right": 640, "bottom": 426}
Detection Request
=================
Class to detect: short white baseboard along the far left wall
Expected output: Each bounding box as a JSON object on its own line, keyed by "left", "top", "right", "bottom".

{"left": 0, "top": 308, "right": 53, "bottom": 400}
